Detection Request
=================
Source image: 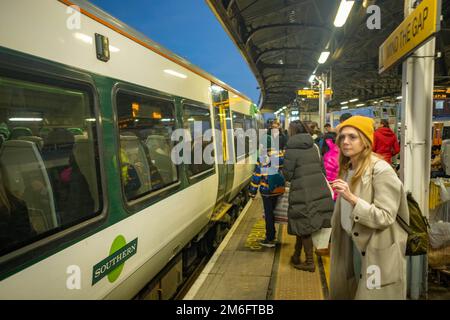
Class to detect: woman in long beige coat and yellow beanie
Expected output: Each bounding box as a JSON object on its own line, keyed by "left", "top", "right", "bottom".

{"left": 330, "top": 116, "right": 409, "bottom": 299}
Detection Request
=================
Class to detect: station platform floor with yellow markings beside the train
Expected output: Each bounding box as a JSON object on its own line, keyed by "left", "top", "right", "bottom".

{"left": 184, "top": 196, "right": 329, "bottom": 300}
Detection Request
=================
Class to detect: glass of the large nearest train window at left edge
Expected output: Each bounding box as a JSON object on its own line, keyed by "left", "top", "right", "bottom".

{"left": 0, "top": 73, "right": 102, "bottom": 255}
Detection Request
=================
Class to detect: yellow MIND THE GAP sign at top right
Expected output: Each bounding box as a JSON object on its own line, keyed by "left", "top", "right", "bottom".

{"left": 378, "top": 0, "right": 441, "bottom": 74}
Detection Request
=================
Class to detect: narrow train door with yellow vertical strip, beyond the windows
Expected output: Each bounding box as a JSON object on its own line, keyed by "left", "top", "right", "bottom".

{"left": 211, "top": 84, "right": 234, "bottom": 202}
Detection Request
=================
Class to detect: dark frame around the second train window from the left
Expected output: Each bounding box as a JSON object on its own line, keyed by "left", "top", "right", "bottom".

{"left": 111, "top": 81, "right": 182, "bottom": 215}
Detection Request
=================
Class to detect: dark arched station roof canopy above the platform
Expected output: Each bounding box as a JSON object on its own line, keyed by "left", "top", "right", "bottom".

{"left": 207, "top": 0, "right": 450, "bottom": 112}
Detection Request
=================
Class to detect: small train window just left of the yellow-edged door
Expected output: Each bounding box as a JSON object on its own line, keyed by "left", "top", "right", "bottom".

{"left": 183, "top": 104, "right": 214, "bottom": 177}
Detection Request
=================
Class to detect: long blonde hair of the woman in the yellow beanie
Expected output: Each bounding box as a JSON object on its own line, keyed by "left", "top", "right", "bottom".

{"left": 336, "top": 127, "right": 380, "bottom": 192}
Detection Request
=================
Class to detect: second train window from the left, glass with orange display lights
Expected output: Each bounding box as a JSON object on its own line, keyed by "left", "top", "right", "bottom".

{"left": 117, "top": 91, "right": 178, "bottom": 201}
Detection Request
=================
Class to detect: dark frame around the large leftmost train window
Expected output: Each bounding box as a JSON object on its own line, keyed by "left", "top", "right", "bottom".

{"left": 0, "top": 49, "right": 109, "bottom": 281}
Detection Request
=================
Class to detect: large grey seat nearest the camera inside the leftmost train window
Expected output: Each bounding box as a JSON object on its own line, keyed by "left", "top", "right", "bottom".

{"left": 0, "top": 140, "right": 58, "bottom": 234}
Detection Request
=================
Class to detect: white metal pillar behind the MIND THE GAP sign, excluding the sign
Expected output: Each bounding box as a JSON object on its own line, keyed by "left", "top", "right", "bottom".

{"left": 400, "top": 0, "right": 436, "bottom": 299}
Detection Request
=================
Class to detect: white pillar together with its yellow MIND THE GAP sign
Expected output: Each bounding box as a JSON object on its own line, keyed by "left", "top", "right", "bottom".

{"left": 379, "top": 0, "right": 441, "bottom": 300}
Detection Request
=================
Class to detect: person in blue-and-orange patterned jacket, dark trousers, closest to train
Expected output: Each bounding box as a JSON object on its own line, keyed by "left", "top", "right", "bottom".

{"left": 249, "top": 134, "right": 284, "bottom": 248}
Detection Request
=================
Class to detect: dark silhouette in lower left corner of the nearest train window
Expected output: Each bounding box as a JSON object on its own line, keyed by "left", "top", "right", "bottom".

{"left": 0, "top": 170, "right": 36, "bottom": 253}
